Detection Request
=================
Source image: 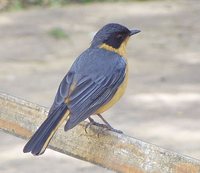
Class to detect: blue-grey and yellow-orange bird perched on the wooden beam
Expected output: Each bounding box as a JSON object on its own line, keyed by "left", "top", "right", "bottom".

{"left": 23, "top": 23, "right": 140, "bottom": 156}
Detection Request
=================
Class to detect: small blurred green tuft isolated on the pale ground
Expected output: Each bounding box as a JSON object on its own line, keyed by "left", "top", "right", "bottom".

{"left": 48, "top": 27, "right": 69, "bottom": 39}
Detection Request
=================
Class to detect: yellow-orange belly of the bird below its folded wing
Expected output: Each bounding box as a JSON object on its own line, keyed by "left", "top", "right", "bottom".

{"left": 96, "top": 63, "right": 128, "bottom": 114}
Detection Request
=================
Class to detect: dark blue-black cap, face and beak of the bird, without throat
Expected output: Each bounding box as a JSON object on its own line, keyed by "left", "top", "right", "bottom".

{"left": 91, "top": 23, "right": 140, "bottom": 49}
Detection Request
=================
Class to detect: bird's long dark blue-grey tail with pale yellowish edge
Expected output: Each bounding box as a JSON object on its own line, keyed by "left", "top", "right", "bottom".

{"left": 23, "top": 103, "right": 69, "bottom": 155}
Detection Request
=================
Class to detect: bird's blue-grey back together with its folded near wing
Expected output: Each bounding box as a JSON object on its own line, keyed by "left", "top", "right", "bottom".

{"left": 65, "top": 48, "right": 126, "bottom": 130}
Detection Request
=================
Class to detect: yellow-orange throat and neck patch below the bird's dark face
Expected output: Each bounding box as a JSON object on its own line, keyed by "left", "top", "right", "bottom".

{"left": 99, "top": 37, "right": 129, "bottom": 57}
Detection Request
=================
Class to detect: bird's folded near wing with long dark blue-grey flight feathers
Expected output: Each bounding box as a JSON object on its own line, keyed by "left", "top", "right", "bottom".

{"left": 65, "top": 65, "right": 125, "bottom": 130}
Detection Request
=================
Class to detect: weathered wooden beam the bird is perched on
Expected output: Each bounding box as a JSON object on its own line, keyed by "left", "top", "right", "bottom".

{"left": 0, "top": 93, "right": 200, "bottom": 173}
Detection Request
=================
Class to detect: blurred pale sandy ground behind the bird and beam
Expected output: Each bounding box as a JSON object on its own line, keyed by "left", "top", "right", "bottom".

{"left": 0, "top": 0, "right": 200, "bottom": 173}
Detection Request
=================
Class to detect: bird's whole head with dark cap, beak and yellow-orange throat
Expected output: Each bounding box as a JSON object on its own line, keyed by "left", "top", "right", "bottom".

{"left": 91, "top": 23, "right": 140, "bottom": 56}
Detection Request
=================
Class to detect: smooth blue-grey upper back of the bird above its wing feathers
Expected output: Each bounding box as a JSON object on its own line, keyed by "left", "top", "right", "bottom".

{"left": 70, "top": 48, "right": 126, "bottom": 80}
